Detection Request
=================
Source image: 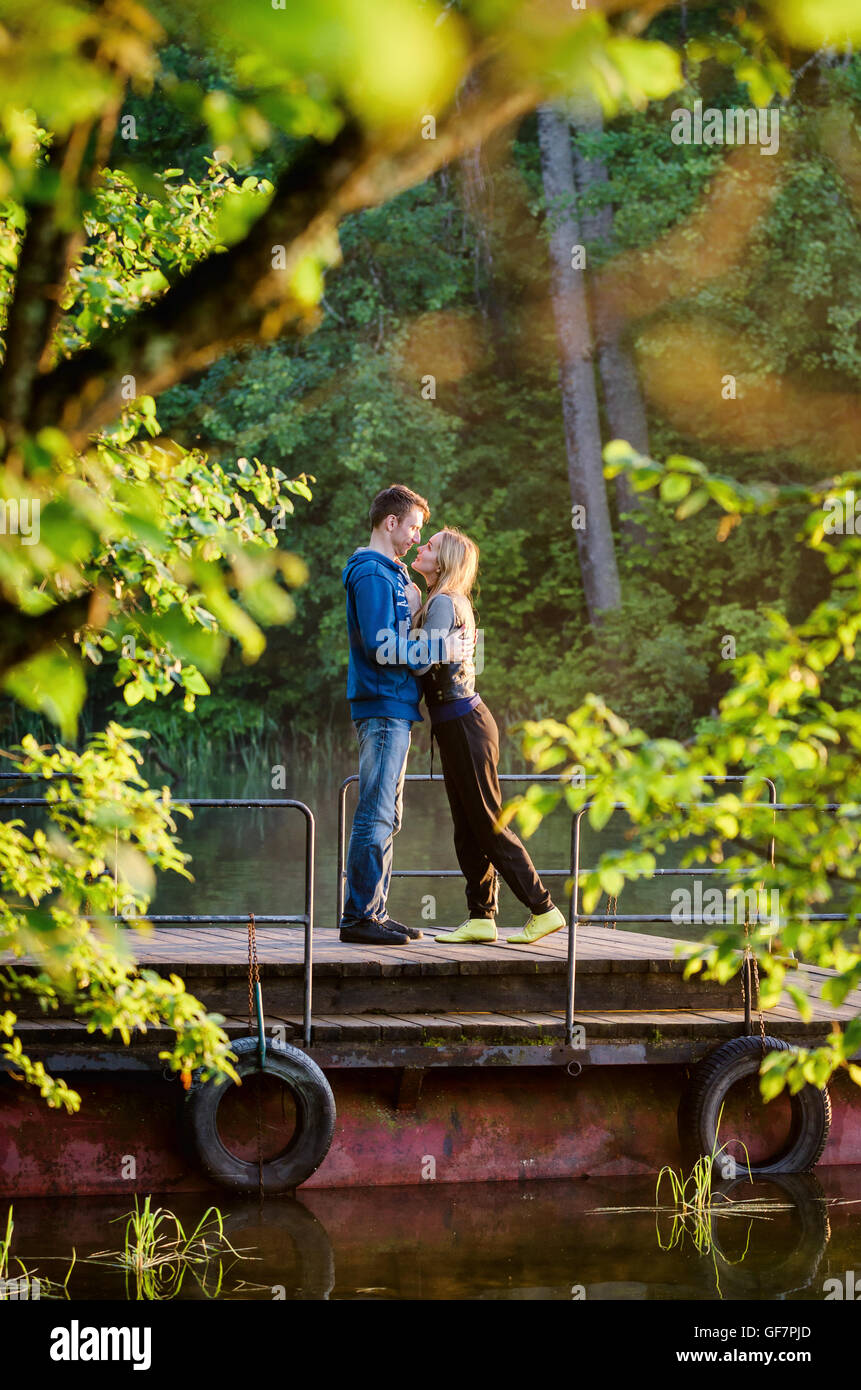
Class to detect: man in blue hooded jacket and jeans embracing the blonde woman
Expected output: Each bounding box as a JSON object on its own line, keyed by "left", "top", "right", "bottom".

{"left": 341, "top": 484, "right": 466, "bottom": 945}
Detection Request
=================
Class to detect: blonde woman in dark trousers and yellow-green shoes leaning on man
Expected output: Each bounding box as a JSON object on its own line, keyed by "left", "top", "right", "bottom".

{"left": 412, "top": 527, "right": 565, "bottom": 944}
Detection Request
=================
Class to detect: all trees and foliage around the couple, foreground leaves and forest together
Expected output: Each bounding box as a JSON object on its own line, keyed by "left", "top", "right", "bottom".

{"left": 0, "top": 0, "right": 861, "bottom": 1106}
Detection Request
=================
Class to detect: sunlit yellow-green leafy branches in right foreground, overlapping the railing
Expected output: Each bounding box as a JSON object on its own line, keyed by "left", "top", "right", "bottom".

{"left": 505, "top": 442, "right": 861, "bottom": 1099}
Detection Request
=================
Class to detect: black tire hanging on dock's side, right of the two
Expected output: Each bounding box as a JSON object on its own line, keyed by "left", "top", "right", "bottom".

{"left": 679, "top": 1036, "right": 832, "bottom": 1177}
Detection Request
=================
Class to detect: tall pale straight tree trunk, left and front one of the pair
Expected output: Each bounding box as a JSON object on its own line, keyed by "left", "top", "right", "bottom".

{"left": 538, "top": 106, "right": 622, "bottom": 623}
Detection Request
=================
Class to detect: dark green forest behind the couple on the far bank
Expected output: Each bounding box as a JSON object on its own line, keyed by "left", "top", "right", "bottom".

{"left": 8, "top": 4, "right": 861, "bottom": 770}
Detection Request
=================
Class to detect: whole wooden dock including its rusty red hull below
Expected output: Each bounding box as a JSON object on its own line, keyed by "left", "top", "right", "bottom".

{"left": 6, "top": 924, "right": 861, "bottom": 1200}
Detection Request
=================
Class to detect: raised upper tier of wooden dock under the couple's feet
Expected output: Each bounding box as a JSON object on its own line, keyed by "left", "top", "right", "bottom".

{"left": 6, "top": 924, "right": 861, "bottom": 1036}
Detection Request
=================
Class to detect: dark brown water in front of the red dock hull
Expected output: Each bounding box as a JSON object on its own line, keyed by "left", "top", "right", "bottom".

{"left": 6, "top": 1168, "right": 861, "bottom": 1302}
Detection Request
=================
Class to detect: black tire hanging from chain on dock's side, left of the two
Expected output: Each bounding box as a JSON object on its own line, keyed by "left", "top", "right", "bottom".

{"left": 184, "top": 1037, "right": 335, "bottom": 1193}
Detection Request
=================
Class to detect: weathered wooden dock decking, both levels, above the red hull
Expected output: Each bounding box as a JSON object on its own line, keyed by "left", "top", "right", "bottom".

{"left": 8, "top": 926, "right": 861, "bottom": 1070}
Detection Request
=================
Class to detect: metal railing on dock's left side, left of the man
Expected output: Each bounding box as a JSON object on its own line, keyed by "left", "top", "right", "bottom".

{"left": 0, "top": 789, "right": 316, "bottom": 1047}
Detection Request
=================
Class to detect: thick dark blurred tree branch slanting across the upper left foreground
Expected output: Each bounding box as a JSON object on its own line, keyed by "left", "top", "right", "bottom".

{"left": 26, "top": 78, "right": 540, "bottom": 449}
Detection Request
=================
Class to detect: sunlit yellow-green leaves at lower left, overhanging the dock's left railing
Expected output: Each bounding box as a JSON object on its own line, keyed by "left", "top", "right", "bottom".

{"left": 0, "top": 723, "right": 236, "bottom": 1111}
